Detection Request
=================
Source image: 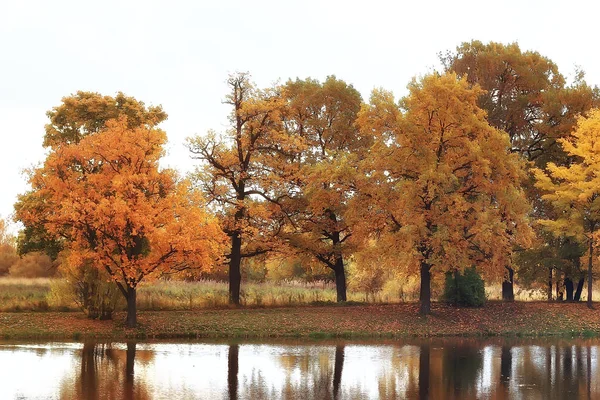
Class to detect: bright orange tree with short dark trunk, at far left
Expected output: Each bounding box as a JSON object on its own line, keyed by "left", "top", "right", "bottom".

{"left": 19, "top": 117, "right": 221, "bottom": 327}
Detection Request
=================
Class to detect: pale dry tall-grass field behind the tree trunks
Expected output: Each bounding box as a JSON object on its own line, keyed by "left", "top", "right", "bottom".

{"left": 0, "top": 277, "right": 600, "bottom": 312}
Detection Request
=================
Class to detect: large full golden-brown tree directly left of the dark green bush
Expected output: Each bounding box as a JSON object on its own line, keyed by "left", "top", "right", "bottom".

{"left": 359, "top": 74, "right": 530, "bottom": 314}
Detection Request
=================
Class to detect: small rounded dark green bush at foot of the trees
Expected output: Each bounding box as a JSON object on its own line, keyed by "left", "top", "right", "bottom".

{"left": 442, "top": 267, "right": 485, "bottom": 307}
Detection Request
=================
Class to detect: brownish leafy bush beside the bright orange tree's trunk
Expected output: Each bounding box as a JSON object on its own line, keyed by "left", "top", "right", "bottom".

{"left": 49, "top": 264, "right": 124, "bottom": 319}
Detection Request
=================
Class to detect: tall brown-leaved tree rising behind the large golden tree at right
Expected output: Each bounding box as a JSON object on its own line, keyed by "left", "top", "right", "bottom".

{"left": 441, "top": 41, "right": 600, "bottom": 300}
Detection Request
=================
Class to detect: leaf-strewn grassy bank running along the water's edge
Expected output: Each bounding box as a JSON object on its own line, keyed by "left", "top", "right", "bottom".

{"left": 0, "top": 302, "right": 600, "bottom": 340}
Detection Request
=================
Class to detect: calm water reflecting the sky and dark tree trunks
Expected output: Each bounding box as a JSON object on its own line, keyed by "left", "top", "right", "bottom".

{"left": 0, "top": 339, "right": 600, "bottom": 400}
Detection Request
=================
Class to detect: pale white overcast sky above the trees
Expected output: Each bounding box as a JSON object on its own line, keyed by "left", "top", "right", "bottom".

{"left": 0, "top": 0, "right": 600, "bottom": 229}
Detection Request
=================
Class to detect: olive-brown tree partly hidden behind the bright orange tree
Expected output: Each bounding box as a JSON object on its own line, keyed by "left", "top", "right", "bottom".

{"left": 15, "top": 91, "right": 167, "bottom": 260}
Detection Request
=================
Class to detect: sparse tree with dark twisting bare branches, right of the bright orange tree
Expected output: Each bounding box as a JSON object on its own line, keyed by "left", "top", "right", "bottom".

{"left": 188, "top": 73, "right": 299, "bottom": 305}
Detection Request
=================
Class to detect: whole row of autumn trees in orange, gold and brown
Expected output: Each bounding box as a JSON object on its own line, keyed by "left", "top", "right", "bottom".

{"left": 8, "top": 41, "right": 600, "bottom": 326}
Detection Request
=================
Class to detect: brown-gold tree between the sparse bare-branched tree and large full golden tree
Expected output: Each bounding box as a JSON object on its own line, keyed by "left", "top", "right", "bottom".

{"left": 283, "top": 76, "right": 371, "bottom": 301}
